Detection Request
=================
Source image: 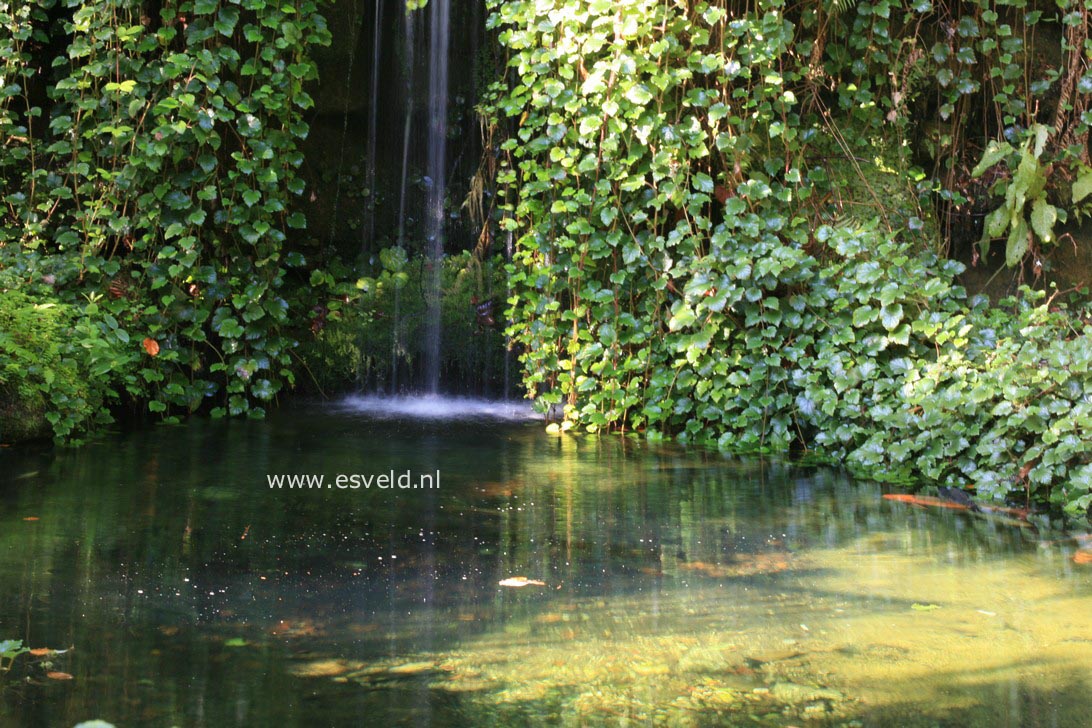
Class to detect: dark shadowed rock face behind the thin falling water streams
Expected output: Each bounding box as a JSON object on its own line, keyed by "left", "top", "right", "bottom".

{"left": 302, "top": 0, "right": 494, "bottom": 262}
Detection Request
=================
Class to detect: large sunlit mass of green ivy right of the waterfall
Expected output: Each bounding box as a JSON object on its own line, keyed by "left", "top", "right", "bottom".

{"left": 488, "top": 0, "right": 1088, "bottom": 517}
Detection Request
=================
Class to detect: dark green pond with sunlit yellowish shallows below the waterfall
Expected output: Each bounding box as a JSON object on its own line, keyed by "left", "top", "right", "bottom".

{"left": 0, "top": 399, "right": 1092, "bottom": 727}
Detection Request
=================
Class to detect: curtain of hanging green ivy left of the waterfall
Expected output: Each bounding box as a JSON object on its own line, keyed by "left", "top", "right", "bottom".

{"left": 0, "top": 0, "right": 330, "bottom": 432}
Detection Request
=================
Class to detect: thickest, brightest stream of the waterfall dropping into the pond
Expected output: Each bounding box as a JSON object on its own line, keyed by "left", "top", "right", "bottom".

{"left": 424, "top": 0, "right": 451, "bottom": 394}
